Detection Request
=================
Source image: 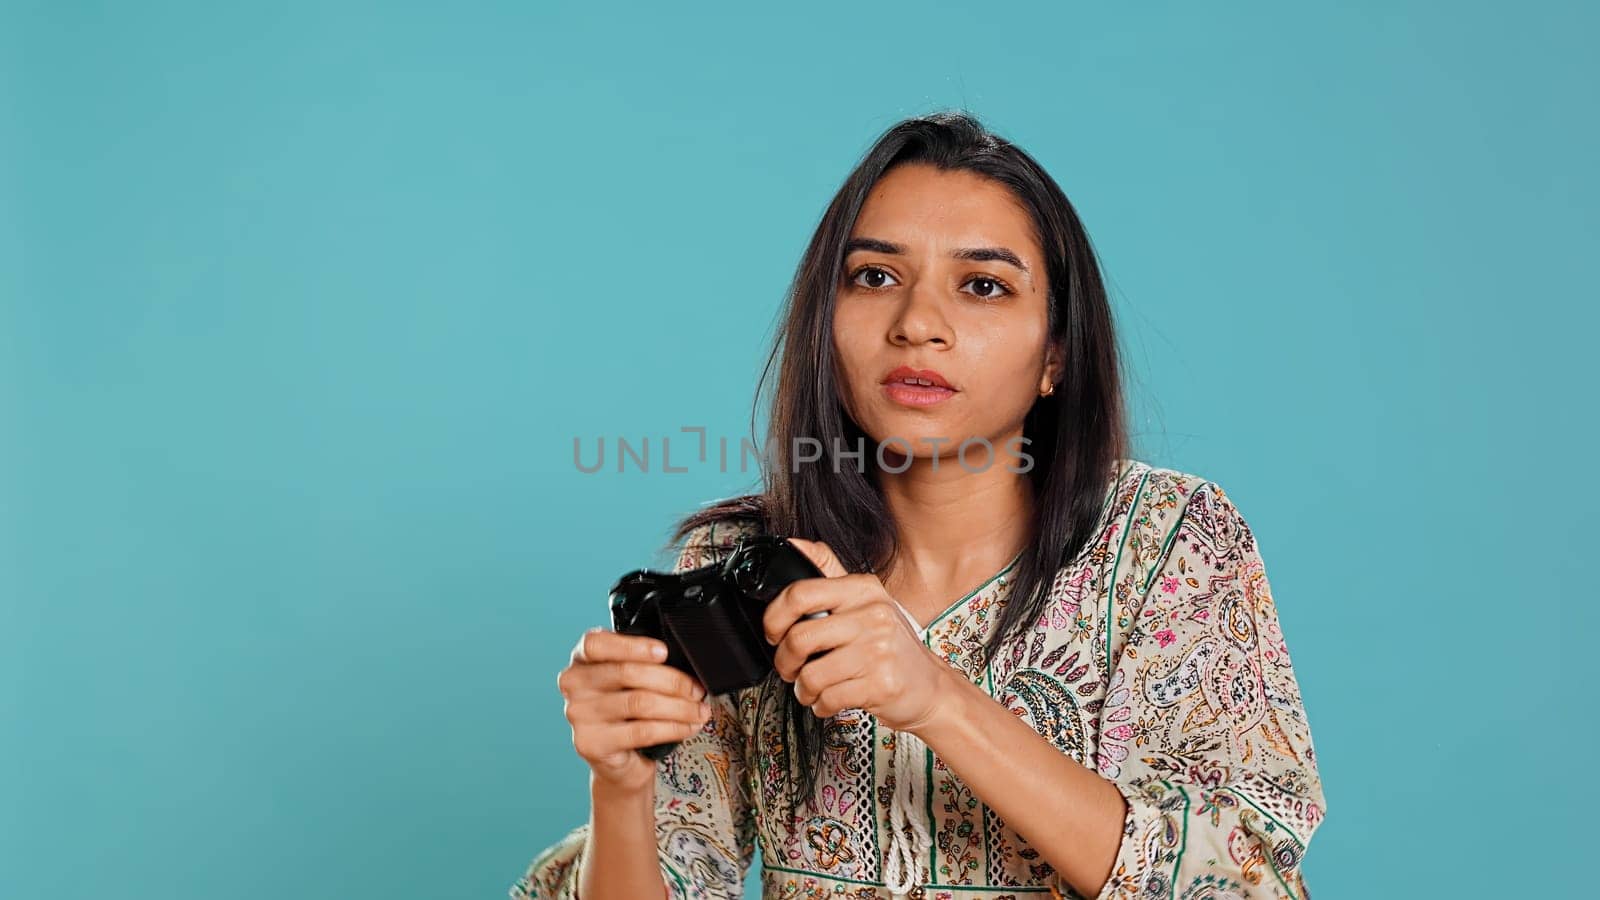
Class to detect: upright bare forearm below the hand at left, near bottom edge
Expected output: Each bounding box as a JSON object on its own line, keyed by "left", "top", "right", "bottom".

{"left": 578, "top": 777, "right": 667, "bottom": 900}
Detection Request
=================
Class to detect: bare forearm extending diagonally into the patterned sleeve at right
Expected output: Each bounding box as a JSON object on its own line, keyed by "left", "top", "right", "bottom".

{"left": 915, "top": 669, "right": 1128, "bottom": 897}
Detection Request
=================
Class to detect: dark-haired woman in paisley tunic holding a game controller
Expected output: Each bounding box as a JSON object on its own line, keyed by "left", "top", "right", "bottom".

{"left": 510, "top": 114, "right": 1325, "bottom": 900}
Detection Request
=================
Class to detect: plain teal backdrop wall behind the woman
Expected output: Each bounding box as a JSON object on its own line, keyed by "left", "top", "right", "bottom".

{"left": 0, "top": 2, "right": 1600, "bottom": 900}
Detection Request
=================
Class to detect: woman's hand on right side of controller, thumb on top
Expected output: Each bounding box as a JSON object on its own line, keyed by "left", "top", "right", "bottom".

{"left": 762, "top": 538, "right": 950, "bottom": 732}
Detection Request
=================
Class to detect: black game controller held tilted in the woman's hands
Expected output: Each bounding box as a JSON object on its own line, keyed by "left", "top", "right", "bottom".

{"left": 611, "top": 535, "right": 827, "bottom": 761}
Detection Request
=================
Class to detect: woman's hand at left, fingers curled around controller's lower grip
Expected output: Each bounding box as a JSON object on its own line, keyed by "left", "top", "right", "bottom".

{"left": 555, "top": 628, "right": 710, "bottom": 791}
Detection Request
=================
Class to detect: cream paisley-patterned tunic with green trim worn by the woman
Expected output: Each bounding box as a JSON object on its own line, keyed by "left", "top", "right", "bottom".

{"left": 510, "top": 460, "right": 1326, "bottom": 900}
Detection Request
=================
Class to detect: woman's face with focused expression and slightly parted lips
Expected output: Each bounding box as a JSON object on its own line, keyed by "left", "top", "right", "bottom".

{"left": 834, "top": 163, "right": 1056, "bottom": 468}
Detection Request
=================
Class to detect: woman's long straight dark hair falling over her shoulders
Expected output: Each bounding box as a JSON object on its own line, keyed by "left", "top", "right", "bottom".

{"left": 674, "top": 110, "right": 1128, "bottom": 818}
